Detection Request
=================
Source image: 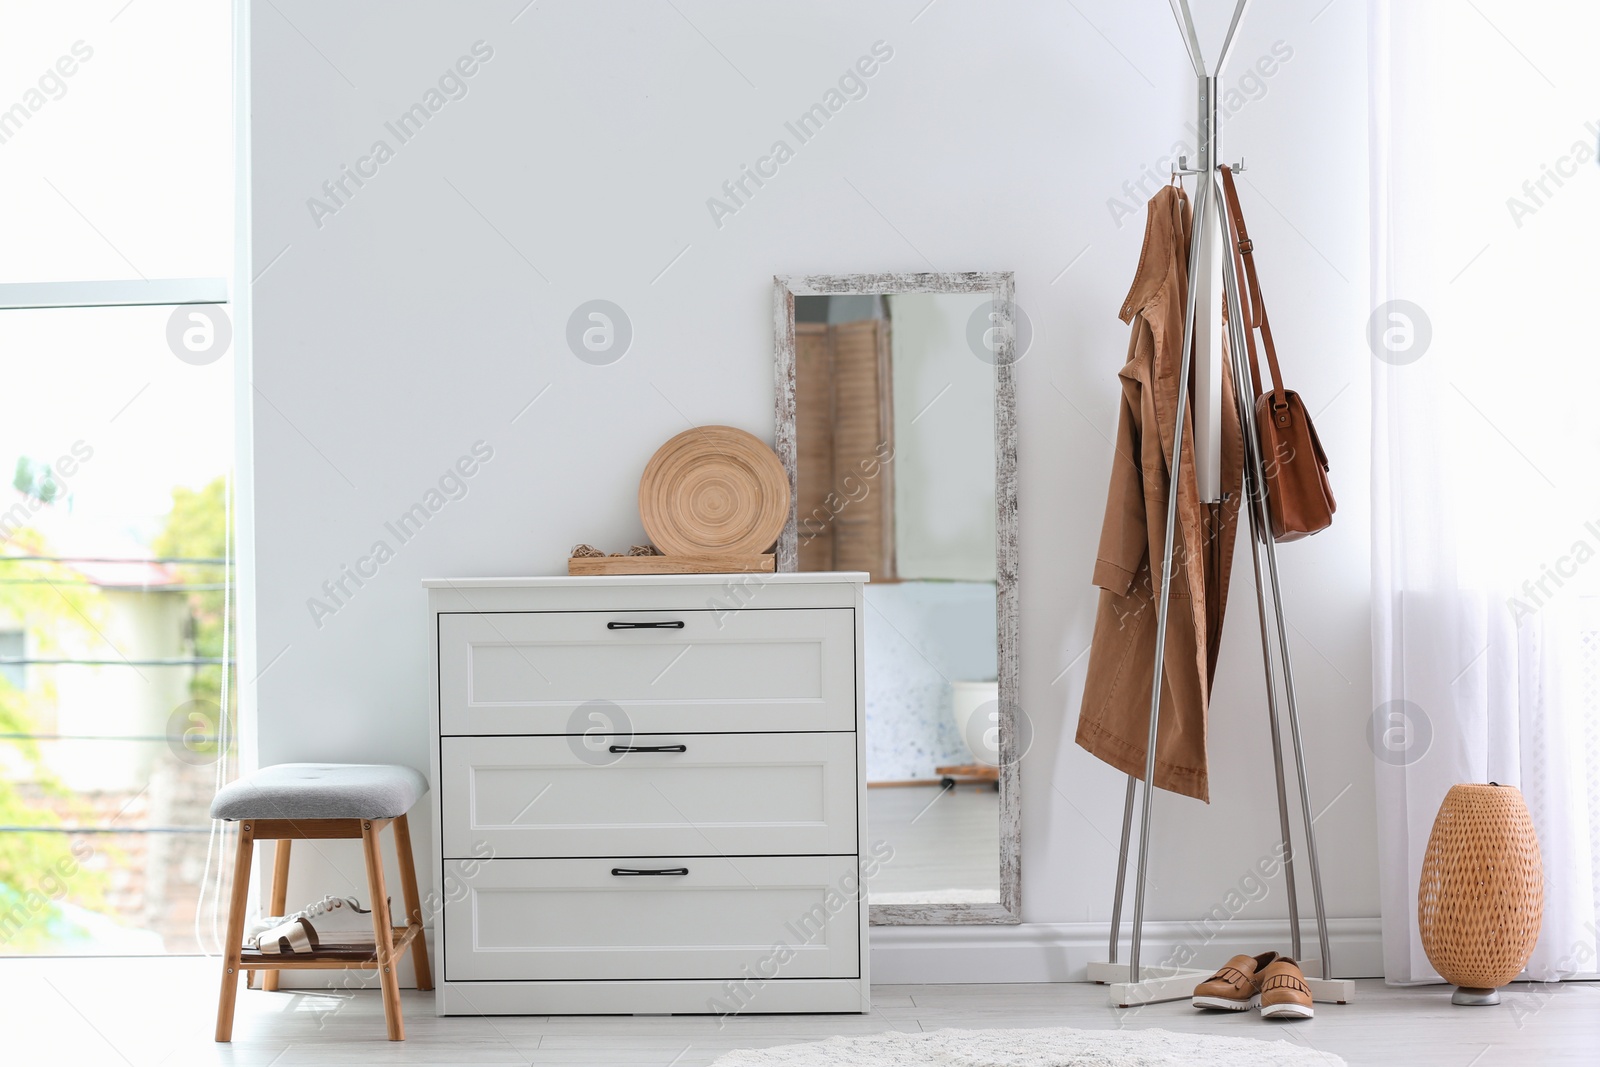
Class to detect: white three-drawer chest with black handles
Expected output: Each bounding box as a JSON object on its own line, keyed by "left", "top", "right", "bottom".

{"left": 426, "top": 574, "right": 869, "bottom": 1014}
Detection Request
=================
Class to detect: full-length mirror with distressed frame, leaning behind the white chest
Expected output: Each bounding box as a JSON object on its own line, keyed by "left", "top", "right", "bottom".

{"left": 776, "top": 274, "right": 1021, "bottom": 923}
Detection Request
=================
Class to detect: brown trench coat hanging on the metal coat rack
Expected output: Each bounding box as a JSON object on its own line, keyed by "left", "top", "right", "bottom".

{"left": 1077, "top": 186, "right": 1243, "bottom": 801}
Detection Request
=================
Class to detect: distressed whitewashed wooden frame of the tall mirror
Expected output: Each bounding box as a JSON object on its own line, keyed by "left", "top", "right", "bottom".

{"left": 773, "top": 272, "right": 1024, "bottom": 926}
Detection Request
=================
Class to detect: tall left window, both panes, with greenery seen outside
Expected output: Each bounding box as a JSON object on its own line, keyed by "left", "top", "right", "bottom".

{"left": 0, "top": 0, "right": 235, "bottom": 955}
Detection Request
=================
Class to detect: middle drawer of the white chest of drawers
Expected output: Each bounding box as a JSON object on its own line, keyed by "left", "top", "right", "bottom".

{"left": 440, "top": 733, "right": 856, "bottom": 859}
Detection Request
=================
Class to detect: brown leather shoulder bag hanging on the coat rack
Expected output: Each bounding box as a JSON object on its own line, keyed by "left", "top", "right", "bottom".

{"left": 1221, "top": 166, "right": 1338, "bottom": 541}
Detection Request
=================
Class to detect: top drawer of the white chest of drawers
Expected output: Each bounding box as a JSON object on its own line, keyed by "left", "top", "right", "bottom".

{"left": 437, "top": 608, "right": 856, "bottom": 736}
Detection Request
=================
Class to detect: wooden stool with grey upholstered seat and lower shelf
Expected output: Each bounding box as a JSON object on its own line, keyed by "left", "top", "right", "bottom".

{"left": 211, "top": 763, "right": 434, "bottom": 1041}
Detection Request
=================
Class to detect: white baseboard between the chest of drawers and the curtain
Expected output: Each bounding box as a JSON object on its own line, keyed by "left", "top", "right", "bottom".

{"left": 872, "top": 918, "right": 1384, "bottom": 985}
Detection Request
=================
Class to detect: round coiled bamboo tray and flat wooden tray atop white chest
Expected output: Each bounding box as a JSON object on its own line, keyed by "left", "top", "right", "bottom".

{"left": 566, "top": 426, "right": 789, "bottom": 574}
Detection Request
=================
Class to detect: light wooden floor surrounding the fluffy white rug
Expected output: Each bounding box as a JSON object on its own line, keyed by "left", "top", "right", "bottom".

{"left": 0, "top": 958, "right": 1600, "bottom": 1067}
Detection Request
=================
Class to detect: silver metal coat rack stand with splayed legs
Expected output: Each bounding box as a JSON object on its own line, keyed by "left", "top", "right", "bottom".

{"left": 1088, "top": 0, "right": 1355, "bottom": 1008}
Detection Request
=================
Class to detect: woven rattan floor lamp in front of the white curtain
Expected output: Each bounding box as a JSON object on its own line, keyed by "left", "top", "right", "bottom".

{"left": 1416, "top": 782, "right": 1544, "bottom": 1005}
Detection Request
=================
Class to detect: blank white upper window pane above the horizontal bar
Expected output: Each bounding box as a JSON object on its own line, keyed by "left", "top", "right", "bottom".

{"left": 0, "top": 0, "right": 234, "bottom": 283}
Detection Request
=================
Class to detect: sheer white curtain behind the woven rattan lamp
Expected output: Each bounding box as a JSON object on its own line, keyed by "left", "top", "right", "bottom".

{"left": 1370, "top": 0, "right": 1600, "bottom": 982}
